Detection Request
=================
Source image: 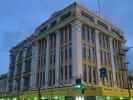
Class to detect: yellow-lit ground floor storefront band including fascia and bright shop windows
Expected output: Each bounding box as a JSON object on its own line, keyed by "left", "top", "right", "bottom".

{"left": 0, "top": 86, "right": 133, "bottom": 100}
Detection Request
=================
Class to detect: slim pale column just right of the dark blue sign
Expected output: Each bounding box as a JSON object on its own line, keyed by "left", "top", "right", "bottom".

{"left": 109, "top": 37, "right": 116, "bottom": 87}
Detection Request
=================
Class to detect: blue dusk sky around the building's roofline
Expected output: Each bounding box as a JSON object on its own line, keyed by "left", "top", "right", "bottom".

{"left": 0, "top": 0, "right": 133, "bottom": 74}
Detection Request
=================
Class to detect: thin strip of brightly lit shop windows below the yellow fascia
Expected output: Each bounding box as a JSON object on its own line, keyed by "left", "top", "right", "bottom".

{"left": 0, "top": 96, "right": 133, "bottom": 100}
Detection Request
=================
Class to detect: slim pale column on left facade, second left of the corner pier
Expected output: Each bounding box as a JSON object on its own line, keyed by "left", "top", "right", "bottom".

{"left": 45, "top": 36, "right": 50, "bottom": 88}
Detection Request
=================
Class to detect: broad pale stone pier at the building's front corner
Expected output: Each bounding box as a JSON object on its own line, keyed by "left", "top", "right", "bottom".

{"left": 71, "top": 20, "right": 83, "bottom": 82}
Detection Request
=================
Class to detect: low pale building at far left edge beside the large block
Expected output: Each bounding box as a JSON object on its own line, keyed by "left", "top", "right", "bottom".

{"left": 0, "top": 74, "right": 7, "bottom": 98}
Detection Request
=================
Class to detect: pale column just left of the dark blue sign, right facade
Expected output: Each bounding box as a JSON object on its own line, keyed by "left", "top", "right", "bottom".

{"left": 95, "top": 30, "right": 102, "bottom": 85}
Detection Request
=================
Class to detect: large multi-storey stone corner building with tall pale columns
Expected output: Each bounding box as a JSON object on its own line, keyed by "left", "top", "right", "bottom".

{"left": 1, "top": 3, "right": 133, "bottom": 100}
